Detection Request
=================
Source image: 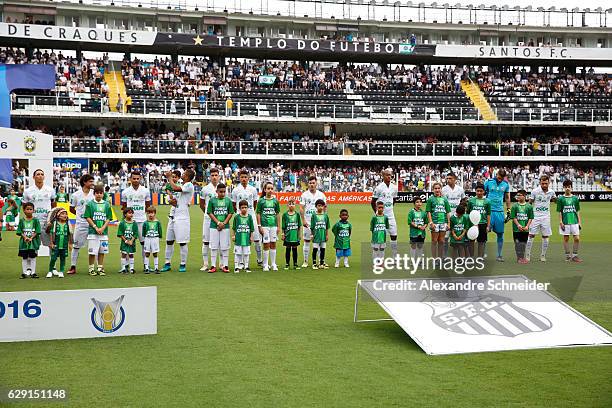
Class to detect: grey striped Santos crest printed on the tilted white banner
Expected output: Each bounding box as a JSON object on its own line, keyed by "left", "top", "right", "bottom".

{"left": 424, "top": 294, "right": 552, "bottom": 337}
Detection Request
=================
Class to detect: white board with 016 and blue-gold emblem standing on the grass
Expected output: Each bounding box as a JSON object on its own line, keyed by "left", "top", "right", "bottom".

{"left": 0, "top": 286, "right": 157, "bottom": 342}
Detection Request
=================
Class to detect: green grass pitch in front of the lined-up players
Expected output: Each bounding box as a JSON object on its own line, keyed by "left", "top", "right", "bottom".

{"left": 0, "top": 203, "right": 612, "bottom": 407}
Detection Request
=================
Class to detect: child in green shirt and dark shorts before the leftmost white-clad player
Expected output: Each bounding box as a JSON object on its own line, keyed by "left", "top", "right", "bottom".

{"left": 17, "top": 203, "right": 41, "bottom": 279}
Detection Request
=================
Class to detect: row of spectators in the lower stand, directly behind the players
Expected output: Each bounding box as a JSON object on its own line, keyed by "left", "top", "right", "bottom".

{"left": 54, "top": 160, "right": 612, "bottom": 196}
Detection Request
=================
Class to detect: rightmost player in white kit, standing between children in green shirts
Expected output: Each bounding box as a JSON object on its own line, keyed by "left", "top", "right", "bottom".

{"left": 525, "top": 175, "right": 557, "bottom": 262}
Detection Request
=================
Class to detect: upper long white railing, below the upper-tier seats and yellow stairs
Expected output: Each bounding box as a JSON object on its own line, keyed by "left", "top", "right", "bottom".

{"left": 11, "top": 95, "right": 612, "bottom": 123}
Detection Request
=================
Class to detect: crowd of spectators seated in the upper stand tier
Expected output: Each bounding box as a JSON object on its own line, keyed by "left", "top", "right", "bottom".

{"left": 0, "top": 48, "right": 612, "bottom": 102}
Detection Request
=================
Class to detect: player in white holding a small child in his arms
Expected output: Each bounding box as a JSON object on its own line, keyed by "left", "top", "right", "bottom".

{"left": 162, "top": 169, "right": 195, "bottom": 272}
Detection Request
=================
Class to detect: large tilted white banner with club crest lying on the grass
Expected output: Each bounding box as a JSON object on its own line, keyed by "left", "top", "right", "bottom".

{"left": 355, "top": 275, "right": 612, "bottom": 354}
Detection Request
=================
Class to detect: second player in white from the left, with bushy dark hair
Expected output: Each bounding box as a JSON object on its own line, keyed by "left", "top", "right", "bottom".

{"left": 67, "top": 174, "right": 94, "bottom": 275}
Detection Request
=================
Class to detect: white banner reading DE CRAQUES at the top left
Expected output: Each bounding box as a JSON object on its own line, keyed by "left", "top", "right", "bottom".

{"left": 0, "top": 23, "right": 157, "bottom": 45}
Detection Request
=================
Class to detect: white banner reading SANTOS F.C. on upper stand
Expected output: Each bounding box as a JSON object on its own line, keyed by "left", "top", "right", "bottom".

{"left": 435, "top": 44, "right": 612, "bottom": 61}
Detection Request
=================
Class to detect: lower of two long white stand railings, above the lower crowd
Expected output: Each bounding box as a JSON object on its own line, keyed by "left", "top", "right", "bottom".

{"left": 53, "top": 137, "right": 612, "bottom": 156}
